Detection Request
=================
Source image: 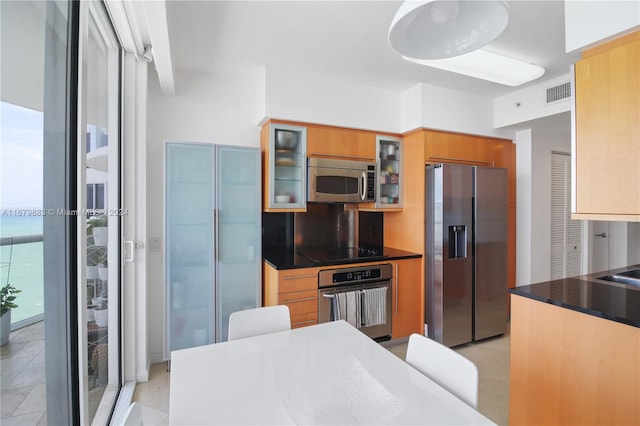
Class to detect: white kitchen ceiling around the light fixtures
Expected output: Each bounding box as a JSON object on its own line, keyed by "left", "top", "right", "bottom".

{"left": 167, "top": 0, "right": 579, "bottom": 97}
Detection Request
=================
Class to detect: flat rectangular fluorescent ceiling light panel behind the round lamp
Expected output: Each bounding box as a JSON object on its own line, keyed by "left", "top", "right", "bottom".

{"left": 402, "top": 49, "right": 545, "bottom": 87}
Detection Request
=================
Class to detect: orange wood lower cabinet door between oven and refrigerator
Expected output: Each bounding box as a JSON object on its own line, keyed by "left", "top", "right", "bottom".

{"left": 391, "top": 259, "right": 424, "bottom": 339}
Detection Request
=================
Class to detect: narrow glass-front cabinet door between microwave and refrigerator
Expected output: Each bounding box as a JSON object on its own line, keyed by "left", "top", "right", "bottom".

{"left": 376, "top": 136, "right": 404, "bottom": 208}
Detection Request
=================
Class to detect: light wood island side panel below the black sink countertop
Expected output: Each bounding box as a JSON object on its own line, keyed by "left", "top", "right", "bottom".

{"left": 509, "top": 295, "right": 640, "bottom": 425}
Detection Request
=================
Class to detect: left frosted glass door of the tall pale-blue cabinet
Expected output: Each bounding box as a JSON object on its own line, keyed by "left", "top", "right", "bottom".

{"left": 165, "top": 143, "right": 215, "bottom": 358}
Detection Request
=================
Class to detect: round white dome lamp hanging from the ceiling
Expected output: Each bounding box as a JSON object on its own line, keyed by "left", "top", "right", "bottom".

{"left": 389, "top": 0, "right": 509, "bottom": 59}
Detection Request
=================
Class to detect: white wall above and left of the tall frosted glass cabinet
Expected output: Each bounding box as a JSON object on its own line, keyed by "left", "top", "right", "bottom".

{"left": 147, "top": 68, "right": 264, "bottom": 363}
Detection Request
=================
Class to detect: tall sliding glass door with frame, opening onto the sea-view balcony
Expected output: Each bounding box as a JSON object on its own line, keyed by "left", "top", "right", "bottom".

{"left": 0, "top": 0, "right": 126, "bottom": 425}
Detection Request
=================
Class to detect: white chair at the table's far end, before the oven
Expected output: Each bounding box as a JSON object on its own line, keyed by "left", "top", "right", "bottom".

{"left": 229, "top": 305, "right": 291, "bottom": 340}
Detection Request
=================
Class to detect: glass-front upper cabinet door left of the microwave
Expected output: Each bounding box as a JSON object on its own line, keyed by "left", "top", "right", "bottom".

{"left": 268, "top": 123, "right": 307, "bottom": 210}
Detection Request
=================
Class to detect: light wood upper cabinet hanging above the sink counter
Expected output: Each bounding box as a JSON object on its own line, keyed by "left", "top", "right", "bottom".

{"left": 572, "top": 31, "right": 640, "bottom": 221}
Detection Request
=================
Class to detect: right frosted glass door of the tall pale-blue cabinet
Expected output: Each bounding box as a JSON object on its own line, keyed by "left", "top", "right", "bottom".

{"left": 215, "top": 145, "right": 262, "bottom": 341}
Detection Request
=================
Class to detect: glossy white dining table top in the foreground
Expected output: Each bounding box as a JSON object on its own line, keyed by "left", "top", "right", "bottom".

{"left": 169, "top": 321, "right": 494, "bottom": 425}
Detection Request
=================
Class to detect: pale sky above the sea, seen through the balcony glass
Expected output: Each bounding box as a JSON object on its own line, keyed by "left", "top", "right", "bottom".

{"left": 0, "top": 102, "right": 43, "bottom": 210}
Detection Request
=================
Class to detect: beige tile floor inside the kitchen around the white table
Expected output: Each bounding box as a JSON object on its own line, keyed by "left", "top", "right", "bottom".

{"left": 133, "top": 328, "right": 509, "bottom": 425}
